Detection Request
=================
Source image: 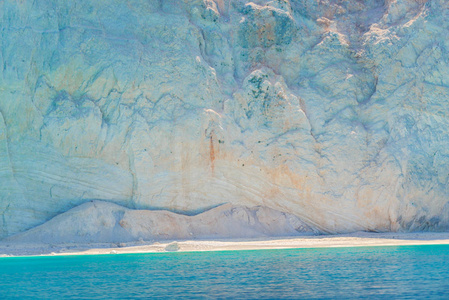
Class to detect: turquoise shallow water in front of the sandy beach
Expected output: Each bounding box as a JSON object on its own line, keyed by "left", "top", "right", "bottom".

{"left": 0, "top": 245, "right": 449, "bottom": 299}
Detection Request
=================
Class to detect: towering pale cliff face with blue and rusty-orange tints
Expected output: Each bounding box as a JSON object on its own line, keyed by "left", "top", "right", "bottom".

{"left": 0, "top": 0, "right": 449, "bottom": 238}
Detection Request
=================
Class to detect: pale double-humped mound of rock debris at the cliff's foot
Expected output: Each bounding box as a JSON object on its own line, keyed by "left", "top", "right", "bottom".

{"left": 6, "top": 201, "right": 318, "bottom": 244}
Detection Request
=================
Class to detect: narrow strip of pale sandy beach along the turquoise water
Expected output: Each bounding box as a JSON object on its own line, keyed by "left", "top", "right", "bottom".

{"left": 0, "top": 232, "right": 449, "bottom": 258}
